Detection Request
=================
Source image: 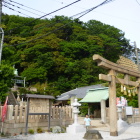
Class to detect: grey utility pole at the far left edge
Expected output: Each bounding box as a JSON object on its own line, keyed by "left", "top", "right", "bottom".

{"left": 0, "top": 0, "right": 4, "bottom": 65}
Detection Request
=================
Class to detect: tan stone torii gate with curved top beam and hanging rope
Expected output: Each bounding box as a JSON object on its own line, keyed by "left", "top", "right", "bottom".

{"left": 93, "top": 54, "right": 140, "bottom": 136}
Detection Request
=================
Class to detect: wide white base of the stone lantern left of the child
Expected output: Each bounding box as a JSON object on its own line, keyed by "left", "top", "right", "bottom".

{"left": 66, "top": 124, "right": 86, "bottom": 134}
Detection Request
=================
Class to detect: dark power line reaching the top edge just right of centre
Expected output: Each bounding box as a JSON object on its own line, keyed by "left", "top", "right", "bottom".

{"left": 4, "top": 0, "right": 81, "bottom": 32}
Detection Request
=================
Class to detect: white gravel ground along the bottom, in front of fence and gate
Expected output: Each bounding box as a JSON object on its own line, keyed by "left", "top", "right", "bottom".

{"left": 0, "top": 123, "right": 140, "bottom": 140}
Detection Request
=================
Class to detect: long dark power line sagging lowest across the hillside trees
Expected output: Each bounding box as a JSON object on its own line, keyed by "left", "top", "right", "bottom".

{"left": 4, "top": 0, "right": 113, "bottom": 46}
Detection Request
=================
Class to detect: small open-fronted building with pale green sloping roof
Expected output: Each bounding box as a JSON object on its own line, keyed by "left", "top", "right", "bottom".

{"left": 79, "top": 87, "right": 109, "bottom": 122}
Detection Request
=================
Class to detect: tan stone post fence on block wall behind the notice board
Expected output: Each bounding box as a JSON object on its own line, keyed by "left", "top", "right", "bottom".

{"left": 0, "top": 105, "right": 73, "bottom": 135}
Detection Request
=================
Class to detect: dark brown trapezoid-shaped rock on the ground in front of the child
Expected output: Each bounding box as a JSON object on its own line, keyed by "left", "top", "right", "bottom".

{"left": 83, "top": 130, "right": 103, "bottom": 140}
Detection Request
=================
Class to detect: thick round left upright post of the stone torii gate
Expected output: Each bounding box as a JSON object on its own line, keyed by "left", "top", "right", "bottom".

{"left": 109, "top": 70, "right": 118, "bottom": 136}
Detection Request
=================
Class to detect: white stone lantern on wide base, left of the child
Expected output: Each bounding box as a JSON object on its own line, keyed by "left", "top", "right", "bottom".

{"left": 66, "top": 99, "right": 86, "bottom": 134}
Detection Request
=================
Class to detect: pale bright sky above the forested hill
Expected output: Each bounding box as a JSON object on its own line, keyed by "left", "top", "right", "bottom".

{"left": 2, "top": 0, "right": 140, "bottom": 48}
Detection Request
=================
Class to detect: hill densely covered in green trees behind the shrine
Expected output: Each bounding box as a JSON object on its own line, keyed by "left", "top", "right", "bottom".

{"left": 2, "top": 14, "right": 132, "bottom": 95}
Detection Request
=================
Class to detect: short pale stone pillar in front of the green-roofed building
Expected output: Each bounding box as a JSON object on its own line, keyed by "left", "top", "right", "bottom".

{"left": 101, "top": 100, "right": 106, "bottom": 123}
